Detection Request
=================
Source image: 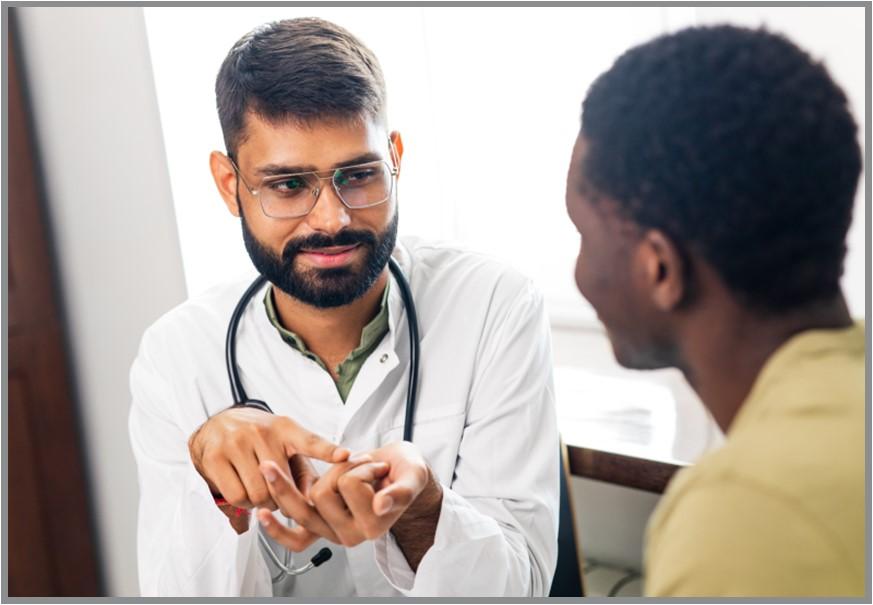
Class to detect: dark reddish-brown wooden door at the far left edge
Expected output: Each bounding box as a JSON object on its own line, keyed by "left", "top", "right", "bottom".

{"left": 4, "top": 14, "right": 103, "bottom": 597}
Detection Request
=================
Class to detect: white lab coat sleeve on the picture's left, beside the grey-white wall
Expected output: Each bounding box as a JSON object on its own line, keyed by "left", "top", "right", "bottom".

{"left": 129, "top": 332, "right": 272, "bottom": 597}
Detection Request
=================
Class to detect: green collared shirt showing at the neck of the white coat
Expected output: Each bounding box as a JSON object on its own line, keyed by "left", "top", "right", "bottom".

{"left": 264, "top": 282, "right": 390, "bottom": 403}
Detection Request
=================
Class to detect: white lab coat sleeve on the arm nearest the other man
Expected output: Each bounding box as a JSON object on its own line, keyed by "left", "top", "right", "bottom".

{"left": 374, "top": 278, "right": 560, "bottom": 597}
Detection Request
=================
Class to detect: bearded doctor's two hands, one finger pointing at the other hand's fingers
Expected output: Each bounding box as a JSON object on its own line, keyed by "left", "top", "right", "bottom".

{"left": 188, "top": 408, "right": 442, "bottom": 552}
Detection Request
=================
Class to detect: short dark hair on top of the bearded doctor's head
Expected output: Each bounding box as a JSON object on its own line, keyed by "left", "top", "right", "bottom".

{"left": 215, "top": 18, "right": 385, "bottom": 157}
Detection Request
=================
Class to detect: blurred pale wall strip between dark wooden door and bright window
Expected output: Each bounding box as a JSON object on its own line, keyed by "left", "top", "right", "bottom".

{"left": 12, "top": 8, "right": 185, "bottom": 596}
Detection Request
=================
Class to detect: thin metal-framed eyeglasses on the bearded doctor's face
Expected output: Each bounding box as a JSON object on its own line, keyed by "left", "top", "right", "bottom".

{"left": 228, "top": 157, "right": 397, "bottom": 218}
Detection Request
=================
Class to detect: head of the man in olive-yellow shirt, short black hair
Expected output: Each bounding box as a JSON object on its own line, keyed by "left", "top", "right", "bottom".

{"left": 567, "top": 26, "right": 861, "bottom": 368}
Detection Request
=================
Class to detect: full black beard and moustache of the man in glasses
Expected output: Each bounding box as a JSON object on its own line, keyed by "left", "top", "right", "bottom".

{"left": 237, "top": 199, "right": 398, "bottom": 309}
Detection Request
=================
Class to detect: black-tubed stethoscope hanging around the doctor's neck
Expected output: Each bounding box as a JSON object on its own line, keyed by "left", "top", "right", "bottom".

{"left": 225, "top": 258, "right": 421, "bottom": 584}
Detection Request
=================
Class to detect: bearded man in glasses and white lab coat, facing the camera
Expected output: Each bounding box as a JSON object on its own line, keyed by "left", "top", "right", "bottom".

{"left": 130, "top": 19, "right": 558, "bottom": 597}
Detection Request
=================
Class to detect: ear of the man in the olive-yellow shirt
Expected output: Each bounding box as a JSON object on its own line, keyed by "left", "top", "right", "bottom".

{"left": 637, "top": 229, "right": 688, "bottom": 312}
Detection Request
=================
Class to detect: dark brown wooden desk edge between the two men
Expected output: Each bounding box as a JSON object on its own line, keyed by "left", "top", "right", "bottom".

{"left": 567, "top": 445, "right": 683, "bottom": 494}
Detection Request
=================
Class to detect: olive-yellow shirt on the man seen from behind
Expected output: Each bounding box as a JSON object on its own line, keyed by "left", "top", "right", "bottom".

{"left": 645, "top": 323, "right": 869, "bottom": 597}
